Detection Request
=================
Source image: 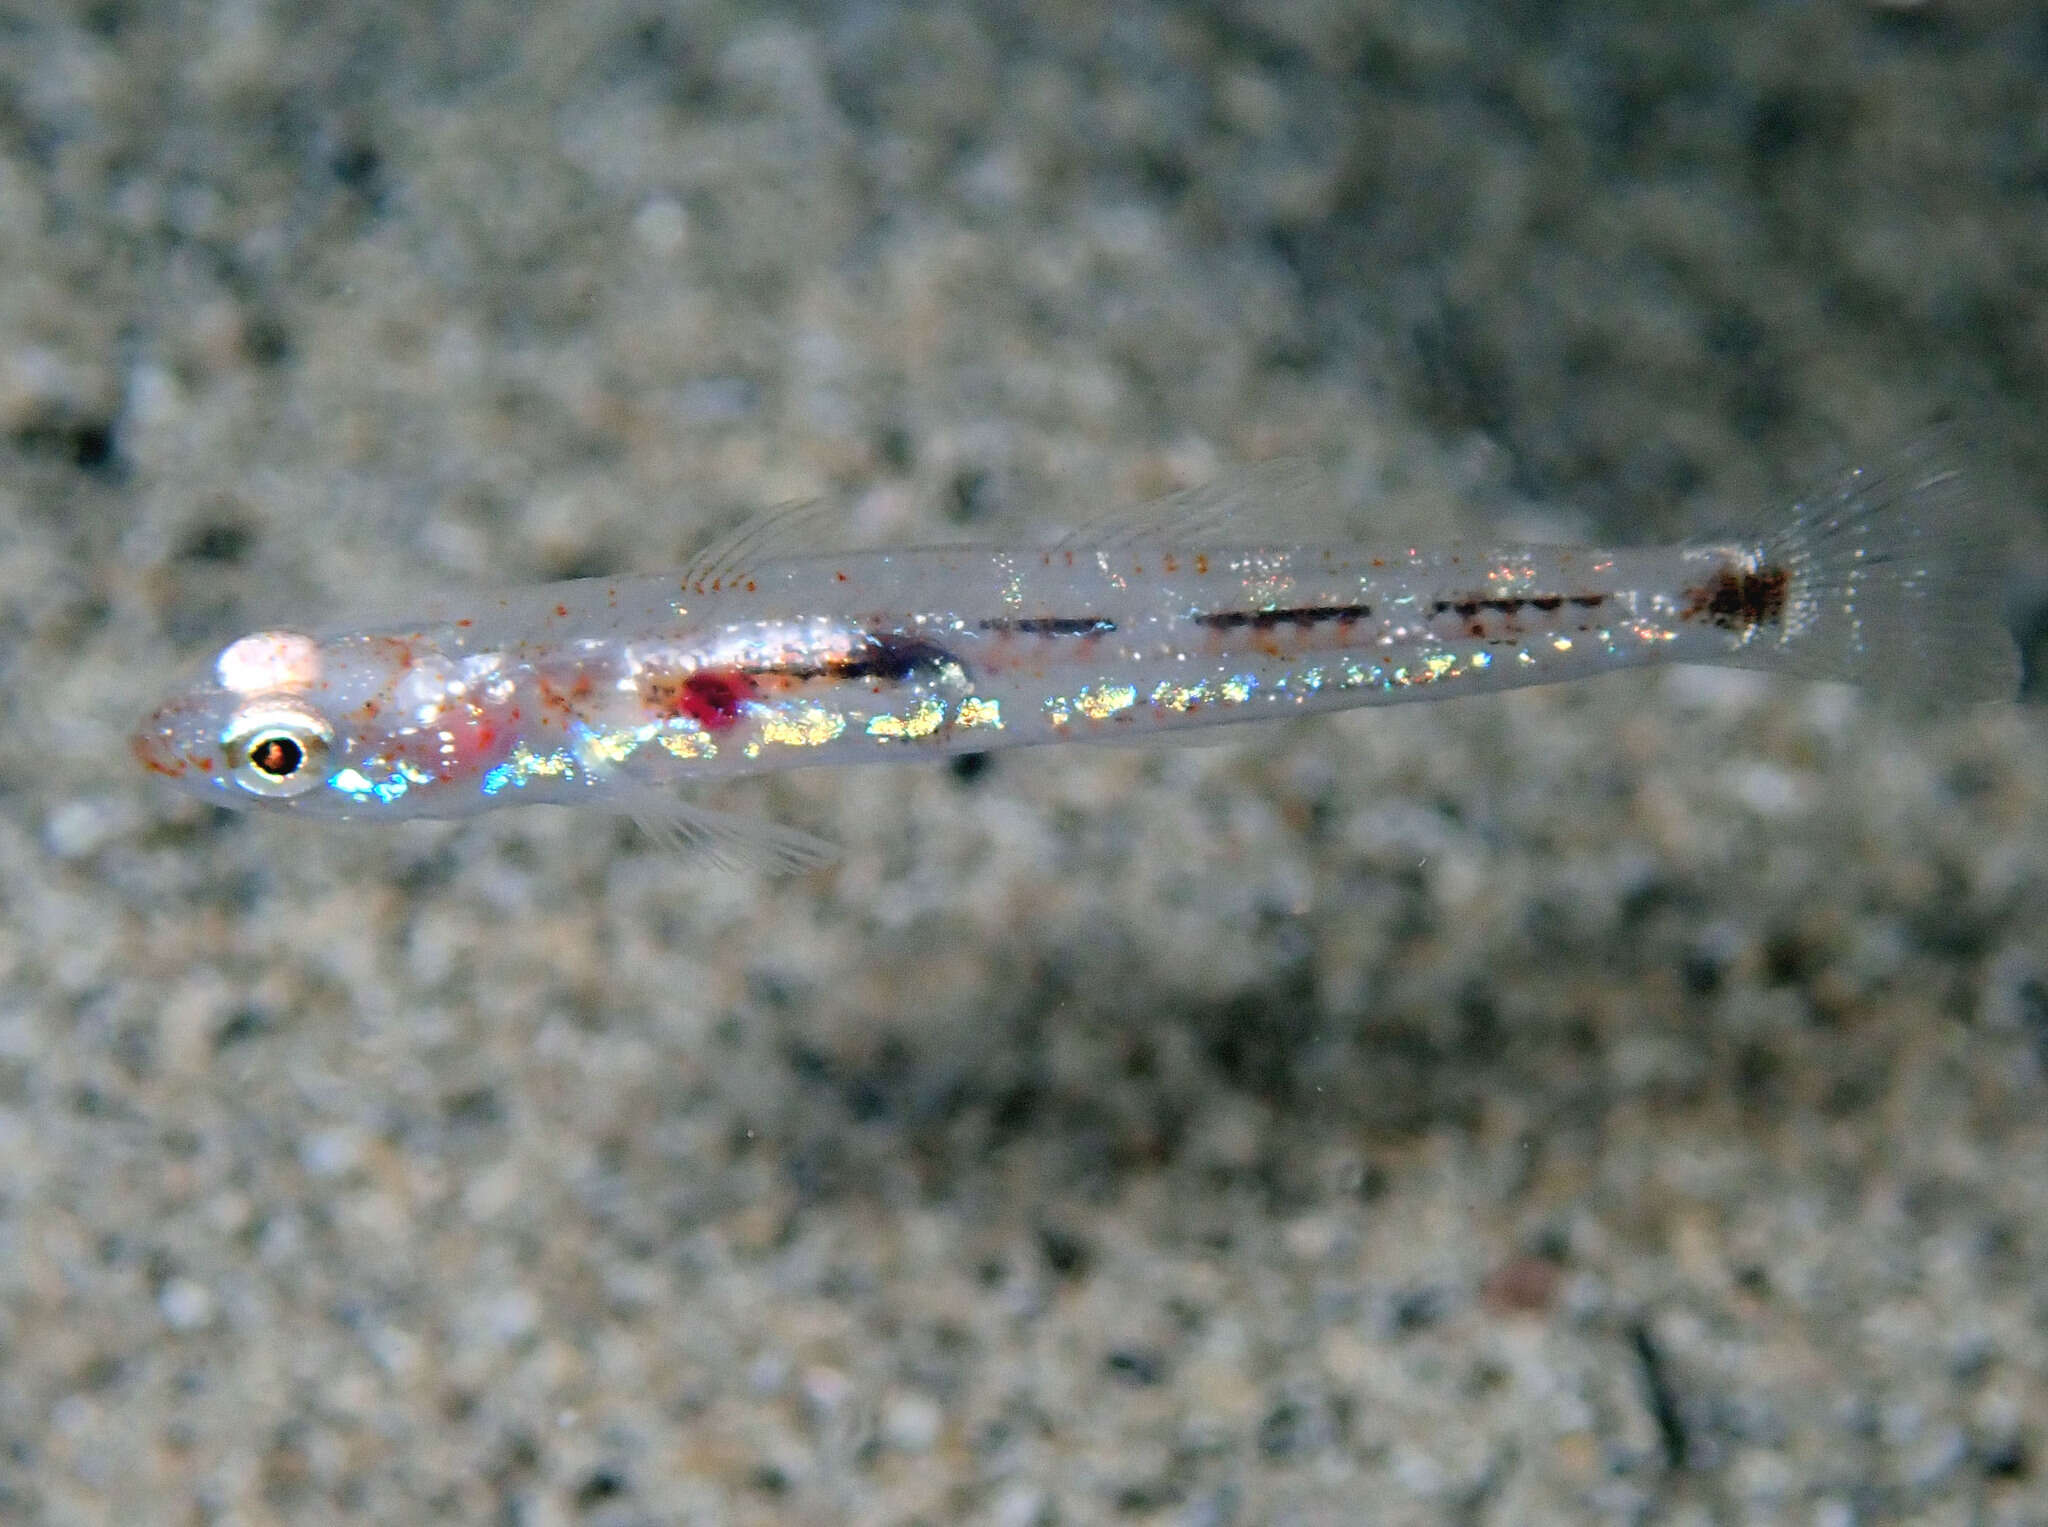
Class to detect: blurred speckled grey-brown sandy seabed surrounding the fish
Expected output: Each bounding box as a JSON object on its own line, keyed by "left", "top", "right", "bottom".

{"left": 0, "top": 0, "right": 2048, "bottom": 1527}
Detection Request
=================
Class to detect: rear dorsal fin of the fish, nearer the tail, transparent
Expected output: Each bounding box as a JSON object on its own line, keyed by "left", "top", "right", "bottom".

{"left": 1059, "top": 456, "right": 1348, "bottom": 553}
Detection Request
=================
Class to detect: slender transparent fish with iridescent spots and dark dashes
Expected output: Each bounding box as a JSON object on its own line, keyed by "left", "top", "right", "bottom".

{"left": 135, "top": 448, "right": 2017, "bottom": 866}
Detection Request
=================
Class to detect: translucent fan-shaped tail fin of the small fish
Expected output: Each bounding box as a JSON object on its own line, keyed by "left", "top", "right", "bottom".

{"left": 1729, "top": 438, "right": 2019, "bottom": 704}
